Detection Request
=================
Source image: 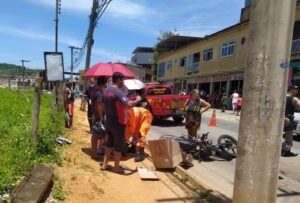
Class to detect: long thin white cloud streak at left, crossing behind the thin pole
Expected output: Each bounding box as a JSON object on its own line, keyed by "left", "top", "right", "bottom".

{"left": 0, "top": 26, "right": 81, "bottom": 46}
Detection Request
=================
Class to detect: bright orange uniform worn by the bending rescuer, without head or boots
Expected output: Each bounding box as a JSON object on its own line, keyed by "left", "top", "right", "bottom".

{"left": 125, "top": 107, "right": 153, "bottom": 148}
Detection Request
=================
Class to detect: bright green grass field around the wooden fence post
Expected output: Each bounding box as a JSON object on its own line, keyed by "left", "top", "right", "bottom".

{"left": 0, "top": 89, "right": 63, "bottom": 195}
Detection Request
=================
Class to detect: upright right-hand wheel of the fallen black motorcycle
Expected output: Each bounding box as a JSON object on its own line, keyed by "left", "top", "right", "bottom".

{"left": 218, "top": 135, "right": 237, "bottom": 158}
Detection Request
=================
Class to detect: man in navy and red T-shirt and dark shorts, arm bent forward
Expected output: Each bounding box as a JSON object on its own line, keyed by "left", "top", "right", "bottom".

{"left": 101, "top": 72, "right": 141, "bottom": 174}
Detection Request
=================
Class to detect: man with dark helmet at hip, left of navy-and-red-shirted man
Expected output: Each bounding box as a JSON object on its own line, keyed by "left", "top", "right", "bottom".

{"left": 91, "top": 76, "right": 107, "bottom": 159}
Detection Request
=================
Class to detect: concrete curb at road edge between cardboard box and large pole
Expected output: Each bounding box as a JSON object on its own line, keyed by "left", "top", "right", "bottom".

{"left": 175, "top": 166, "right": 232, "bottom": 203}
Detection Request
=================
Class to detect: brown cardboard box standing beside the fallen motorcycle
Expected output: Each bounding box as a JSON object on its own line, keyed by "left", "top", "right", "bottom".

{"left": 148, "top": 139, "right": 183, "bottom": 169}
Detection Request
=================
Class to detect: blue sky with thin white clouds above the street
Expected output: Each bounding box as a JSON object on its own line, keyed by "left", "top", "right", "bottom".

{"left": 0, "top": 0, "right": 244, "bottom": 71}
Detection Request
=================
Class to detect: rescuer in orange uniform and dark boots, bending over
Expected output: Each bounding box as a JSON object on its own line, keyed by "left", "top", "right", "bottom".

{"left": 125, "top": 89, "right": 153, "bottom": 162}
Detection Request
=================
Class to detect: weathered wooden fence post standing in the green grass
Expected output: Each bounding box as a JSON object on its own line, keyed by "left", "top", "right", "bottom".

{"left": 31, "top": 77, "right": 43, "bottom": 142}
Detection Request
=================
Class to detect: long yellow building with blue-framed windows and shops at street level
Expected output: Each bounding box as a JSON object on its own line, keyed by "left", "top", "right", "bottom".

{"left": 157, "top": 1, "right": 300, "bottom": 95}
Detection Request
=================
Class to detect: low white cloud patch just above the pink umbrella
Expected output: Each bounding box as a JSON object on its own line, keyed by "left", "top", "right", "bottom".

{"left": 92, "top": 48, "right": 130, "bottom": 62}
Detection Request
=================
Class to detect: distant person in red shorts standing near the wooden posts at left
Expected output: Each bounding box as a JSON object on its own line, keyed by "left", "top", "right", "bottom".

{"left": 64, "top": 83, "right": 75, "bottom": 130}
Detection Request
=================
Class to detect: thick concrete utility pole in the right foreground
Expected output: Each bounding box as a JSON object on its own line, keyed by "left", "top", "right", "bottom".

{"left": 233, "top": 0, "right": 296, "bottom": 203}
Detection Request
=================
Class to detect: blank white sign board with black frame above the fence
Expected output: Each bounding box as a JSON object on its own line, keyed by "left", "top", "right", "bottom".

{"left": 44, "top": 52, "right": 64, "bottom": 81}
